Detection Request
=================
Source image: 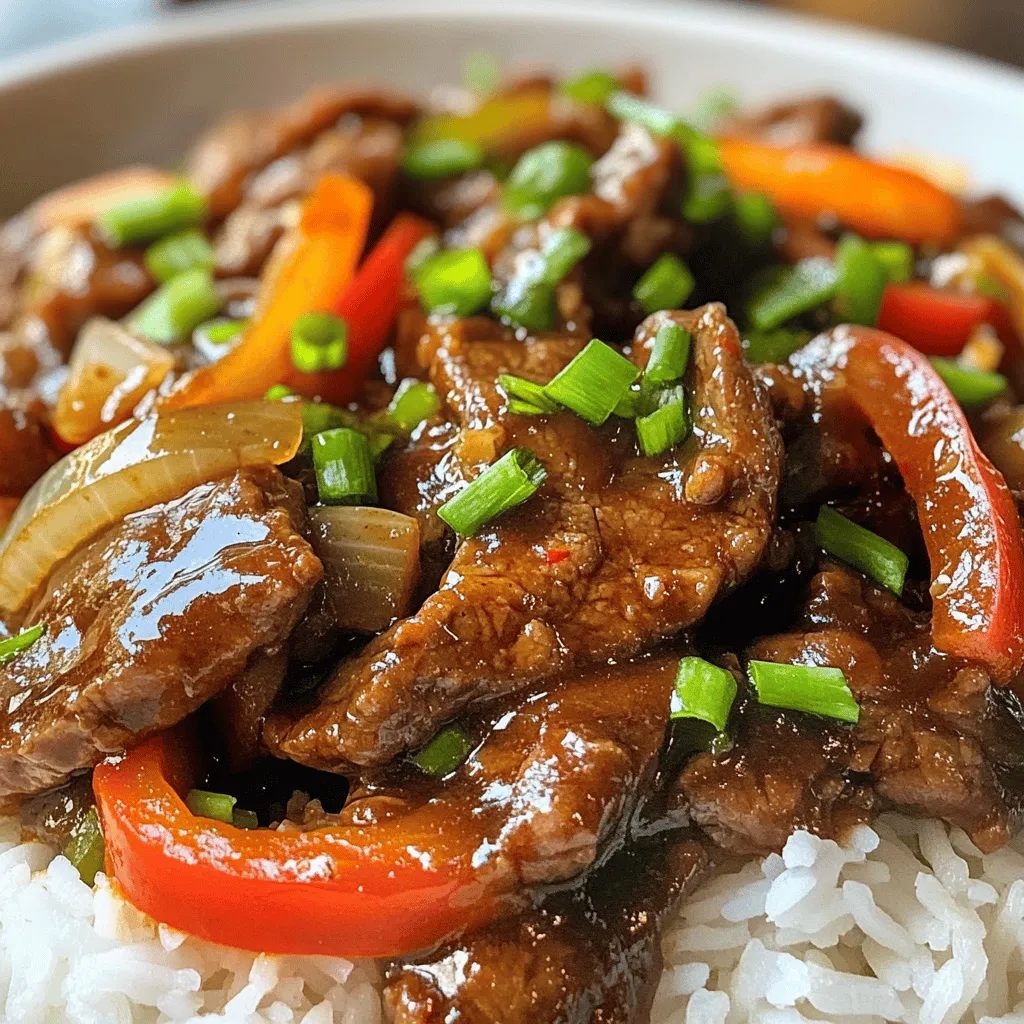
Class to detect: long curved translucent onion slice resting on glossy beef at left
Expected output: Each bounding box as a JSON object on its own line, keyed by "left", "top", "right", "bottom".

{"left": 0, "top": 401, "right": 302, "bottom": 611}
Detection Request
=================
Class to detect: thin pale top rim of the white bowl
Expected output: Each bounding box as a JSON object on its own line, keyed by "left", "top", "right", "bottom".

{"left": 0, "top": 0, "right": 1024, "bottom": 102}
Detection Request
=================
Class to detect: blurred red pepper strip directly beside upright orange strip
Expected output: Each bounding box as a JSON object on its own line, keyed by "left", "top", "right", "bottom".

{"left": 286, "top": 213, "right": 435, "bottom": 404}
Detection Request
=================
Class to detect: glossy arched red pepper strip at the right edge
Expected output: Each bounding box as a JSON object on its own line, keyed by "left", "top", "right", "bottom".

{"left": 790, "top": 326, "right": 1024, "bottom": 683}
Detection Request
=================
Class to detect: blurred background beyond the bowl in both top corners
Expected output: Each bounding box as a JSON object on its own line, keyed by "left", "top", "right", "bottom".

{"left": 0, "top": 0, "right": 1024, "bottom": 68}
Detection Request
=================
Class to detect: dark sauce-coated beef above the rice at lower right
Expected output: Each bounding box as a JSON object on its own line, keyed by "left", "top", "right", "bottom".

{"left": 682, "top": 565, "right": 1024, "bottom": 852}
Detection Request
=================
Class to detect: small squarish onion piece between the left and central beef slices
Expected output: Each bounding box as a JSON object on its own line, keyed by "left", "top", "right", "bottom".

{"left": 309, "top": 506, "right": 420, "bottom": 633}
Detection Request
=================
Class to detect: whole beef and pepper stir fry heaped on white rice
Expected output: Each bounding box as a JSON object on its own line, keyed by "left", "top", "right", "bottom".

{"left": 0, "top": 70, "right": 1024, "bottom": 1024}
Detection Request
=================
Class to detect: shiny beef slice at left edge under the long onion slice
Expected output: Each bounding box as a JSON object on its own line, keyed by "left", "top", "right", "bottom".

{"left": 0, "top": 470, "right": 322, "bottom": 796}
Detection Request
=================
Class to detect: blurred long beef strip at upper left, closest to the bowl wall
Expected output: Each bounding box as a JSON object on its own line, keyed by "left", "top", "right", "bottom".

{"left": 186, "top": 87, "right": 418, "bottom": 219}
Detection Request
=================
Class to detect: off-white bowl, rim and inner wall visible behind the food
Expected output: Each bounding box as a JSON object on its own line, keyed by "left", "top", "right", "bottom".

{"left": 0, "top": 0, "right": 1024, "bottom": 215}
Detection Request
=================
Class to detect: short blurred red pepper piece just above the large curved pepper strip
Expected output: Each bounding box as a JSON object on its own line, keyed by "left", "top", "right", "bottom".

{"left": 878, "top": 281, "right": 1015, "bottom": 355}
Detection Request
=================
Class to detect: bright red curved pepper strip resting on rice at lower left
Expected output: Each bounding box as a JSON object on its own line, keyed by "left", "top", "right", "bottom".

{"left": 93, "top": 728, "right": 496, "bottom": 957}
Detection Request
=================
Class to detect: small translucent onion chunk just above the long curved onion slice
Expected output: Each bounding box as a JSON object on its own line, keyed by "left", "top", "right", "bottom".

{"left": 53, "top": 316, "right": 174, "bottom": 444}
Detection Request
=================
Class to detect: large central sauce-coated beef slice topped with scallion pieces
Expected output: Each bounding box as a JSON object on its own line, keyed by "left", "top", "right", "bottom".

{"left": 266, "top": 305, "right": 781, "bottom": 770}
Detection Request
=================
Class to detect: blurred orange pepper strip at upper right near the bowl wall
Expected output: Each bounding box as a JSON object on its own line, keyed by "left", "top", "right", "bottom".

{"left": 718, "top": 137, "right": 961, "bottom": 245}
